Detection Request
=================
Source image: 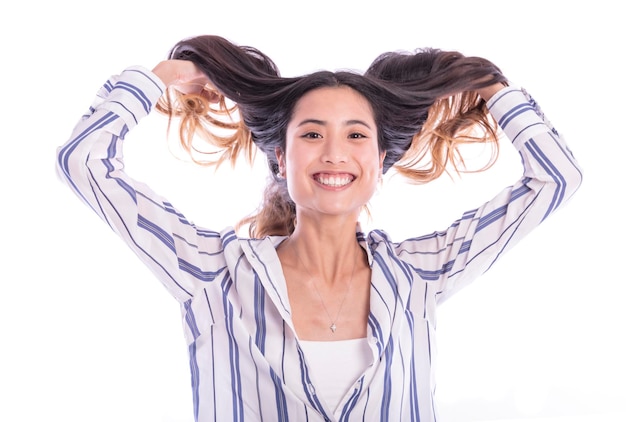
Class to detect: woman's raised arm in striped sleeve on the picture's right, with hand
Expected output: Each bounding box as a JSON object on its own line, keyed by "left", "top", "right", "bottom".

{"left": 397, "top": 84, "right": 582, "bottom": 301}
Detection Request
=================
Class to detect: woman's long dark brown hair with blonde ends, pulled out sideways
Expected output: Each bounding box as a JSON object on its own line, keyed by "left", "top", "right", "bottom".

{"left": 157, "top": 35, "right": 506, "bottom": 237}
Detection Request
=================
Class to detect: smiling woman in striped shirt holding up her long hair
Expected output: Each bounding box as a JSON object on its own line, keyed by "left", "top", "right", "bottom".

{"left": 57, "top": 36, "right": 581, "bottom": 421}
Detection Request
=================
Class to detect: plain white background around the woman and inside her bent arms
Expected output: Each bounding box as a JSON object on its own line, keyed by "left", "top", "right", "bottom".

{"left": 0, "top": 0, "right": 626, "bottom": 422}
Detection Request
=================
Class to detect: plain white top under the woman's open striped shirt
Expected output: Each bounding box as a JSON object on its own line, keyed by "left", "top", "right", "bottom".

{"left": 300, "top": 338, "right": 374, "bottom": 412}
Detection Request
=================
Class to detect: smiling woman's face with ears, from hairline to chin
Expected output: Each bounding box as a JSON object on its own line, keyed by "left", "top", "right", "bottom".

{"left": 276, "top": 87, "right": 385, "bottom": 219}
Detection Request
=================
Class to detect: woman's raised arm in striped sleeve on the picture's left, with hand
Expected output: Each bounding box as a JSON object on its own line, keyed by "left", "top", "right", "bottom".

{"left": 56, "top": 61, "right": 223, "bottom": 301}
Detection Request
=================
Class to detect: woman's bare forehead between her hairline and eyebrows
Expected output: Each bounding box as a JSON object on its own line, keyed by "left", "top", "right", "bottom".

{"left": 292, "top": 86, "right": 374, "bottom": 121}
